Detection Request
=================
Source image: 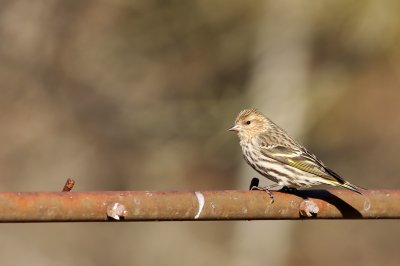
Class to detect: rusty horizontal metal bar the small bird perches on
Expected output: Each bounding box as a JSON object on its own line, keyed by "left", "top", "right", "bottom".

{"left": 0, "top": 190, "right": 400, "bottom": 223}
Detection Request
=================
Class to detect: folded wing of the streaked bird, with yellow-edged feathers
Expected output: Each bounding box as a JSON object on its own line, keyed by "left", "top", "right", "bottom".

{"left": 261, "top": 145, "right": 345, "bottom": 183}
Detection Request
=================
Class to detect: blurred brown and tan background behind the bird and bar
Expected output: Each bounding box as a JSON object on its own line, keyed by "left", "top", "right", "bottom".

{"left": 0, "top": 0, "right": 400, "bottom": 266}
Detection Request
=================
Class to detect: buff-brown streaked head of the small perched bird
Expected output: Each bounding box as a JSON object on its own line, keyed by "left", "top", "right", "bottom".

{"left": 228, "top": 109, "right": 268, "bottom": 140}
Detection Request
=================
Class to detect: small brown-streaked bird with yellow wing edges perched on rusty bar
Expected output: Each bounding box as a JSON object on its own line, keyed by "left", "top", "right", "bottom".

{"left": 229, "top": 109, "right": 361, "bottom": 201}
